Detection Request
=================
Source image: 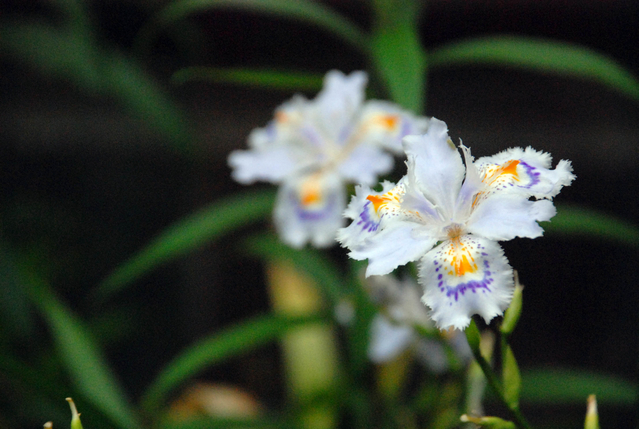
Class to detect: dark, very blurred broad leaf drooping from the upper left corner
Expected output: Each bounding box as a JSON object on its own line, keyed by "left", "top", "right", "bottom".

{"left": 0, "top": 22, "right": 192, "bottom": 154}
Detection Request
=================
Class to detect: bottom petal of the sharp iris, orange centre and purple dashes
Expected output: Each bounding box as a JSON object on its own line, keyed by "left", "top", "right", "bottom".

{"left": 419, "top": 235, "right": 514, "bottom": 330}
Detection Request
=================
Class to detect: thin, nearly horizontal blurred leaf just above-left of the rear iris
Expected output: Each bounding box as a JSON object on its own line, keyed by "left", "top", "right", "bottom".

{"left": 171, "top": 67, "right": 324, "bottom": 91}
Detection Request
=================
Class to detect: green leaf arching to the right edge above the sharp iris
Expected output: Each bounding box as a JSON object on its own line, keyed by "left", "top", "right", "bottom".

{"left": 428, "top": 36, "right": 639, "bottom": 100}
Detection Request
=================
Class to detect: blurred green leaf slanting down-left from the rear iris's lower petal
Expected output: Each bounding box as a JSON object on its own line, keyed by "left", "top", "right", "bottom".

{"left": 96, "top": 191, "right": 274, "bottom": 299}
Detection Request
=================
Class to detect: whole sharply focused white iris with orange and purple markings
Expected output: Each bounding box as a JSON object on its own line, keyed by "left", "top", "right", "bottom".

{"left": 338, "top": 118, "right": 575, "bottom": 329}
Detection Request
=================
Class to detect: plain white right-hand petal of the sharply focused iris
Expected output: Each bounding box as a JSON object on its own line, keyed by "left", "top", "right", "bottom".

{"left": 466, "top": 194, "right": 557, "bottom": 241}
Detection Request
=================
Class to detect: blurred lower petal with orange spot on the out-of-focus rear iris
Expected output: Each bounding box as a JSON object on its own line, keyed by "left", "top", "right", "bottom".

{"left": 274, "top": 173, "right": 346, "bottom": 248}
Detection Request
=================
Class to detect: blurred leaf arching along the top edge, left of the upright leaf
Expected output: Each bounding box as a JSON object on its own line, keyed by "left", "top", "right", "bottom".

{"left": 135, "top": 0, "right": 368, "bottom": 54}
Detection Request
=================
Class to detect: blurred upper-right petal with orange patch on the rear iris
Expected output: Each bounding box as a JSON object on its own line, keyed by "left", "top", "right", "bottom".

{"left": 353, "top": 100, "right": 429, "bottom": 154}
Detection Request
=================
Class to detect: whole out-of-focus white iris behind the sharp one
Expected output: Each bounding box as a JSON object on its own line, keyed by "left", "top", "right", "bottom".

{"left": 229, "top": 71, "right": 428, "bottom": 247}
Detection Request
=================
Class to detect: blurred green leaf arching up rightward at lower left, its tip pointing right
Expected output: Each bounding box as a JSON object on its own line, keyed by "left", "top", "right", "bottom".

{"left": 142, "top": 315, "right": 324, "bottom": 414}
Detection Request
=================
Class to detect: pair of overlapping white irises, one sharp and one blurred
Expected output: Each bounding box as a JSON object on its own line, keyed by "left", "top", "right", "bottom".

{"left": 229, "top": 71, "right": 575, "bottom": 329}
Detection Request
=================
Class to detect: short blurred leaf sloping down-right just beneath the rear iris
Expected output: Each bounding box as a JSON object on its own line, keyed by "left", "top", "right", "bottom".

{"left": 245, "top": 234, "right": 348, "bottom": 303}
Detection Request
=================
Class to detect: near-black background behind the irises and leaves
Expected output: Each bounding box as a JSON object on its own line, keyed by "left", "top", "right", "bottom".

{"left": 0, "top": 0, "right": 639, "bottom": 428}
